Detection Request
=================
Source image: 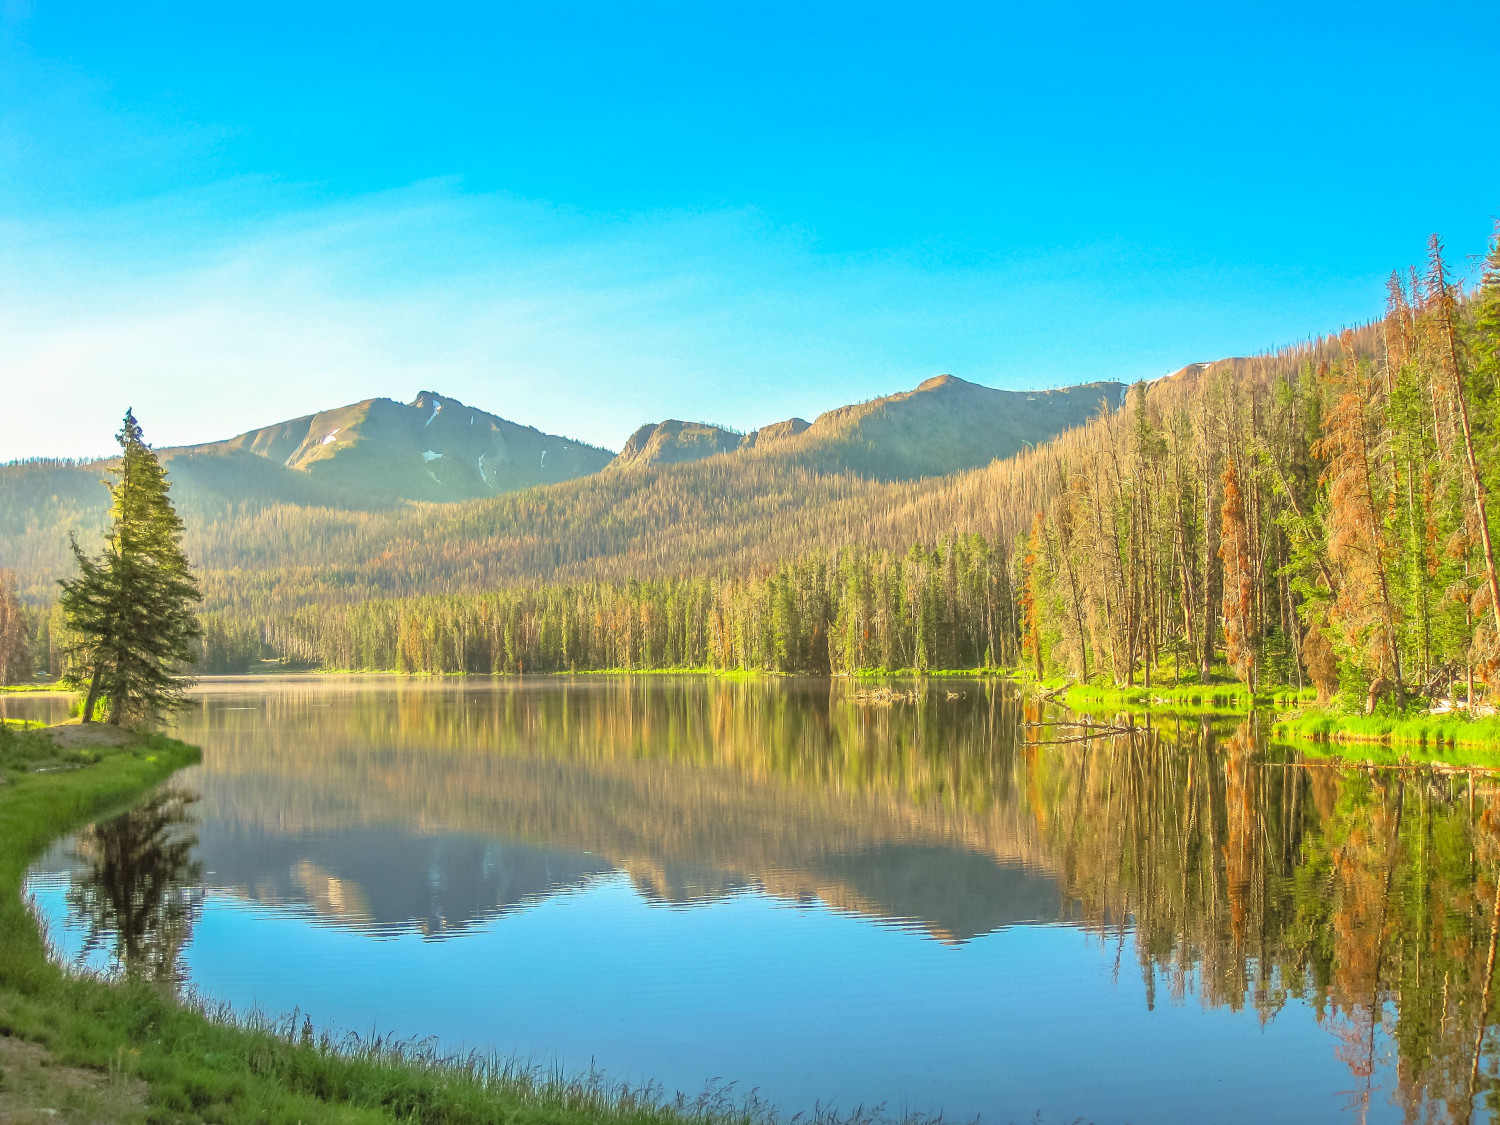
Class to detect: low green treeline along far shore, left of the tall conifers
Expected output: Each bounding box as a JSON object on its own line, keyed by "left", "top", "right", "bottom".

{"left": 225, "top": 536, "right": 1019, "bottom": 674}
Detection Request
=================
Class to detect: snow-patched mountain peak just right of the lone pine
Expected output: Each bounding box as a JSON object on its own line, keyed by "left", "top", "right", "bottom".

{"left": 162, "top": 390, "right": 611, "bottom": 506}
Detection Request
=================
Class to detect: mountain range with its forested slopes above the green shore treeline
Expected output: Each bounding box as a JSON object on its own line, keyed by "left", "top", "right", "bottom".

{"left": 0, "top": 377, "right": 1124, "bottom": 611}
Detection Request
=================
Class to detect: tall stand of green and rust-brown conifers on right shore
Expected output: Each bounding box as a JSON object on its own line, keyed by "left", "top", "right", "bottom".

{"left": 1022, "top": 236, "right": 1500, "bottom": 710}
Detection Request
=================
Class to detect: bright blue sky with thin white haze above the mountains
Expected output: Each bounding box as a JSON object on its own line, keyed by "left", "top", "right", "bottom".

{"left": 0, "top": 0, "right": 1500, "bottom": 461}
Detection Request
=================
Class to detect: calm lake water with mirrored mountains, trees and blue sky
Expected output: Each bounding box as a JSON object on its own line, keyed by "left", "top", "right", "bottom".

{"left": 3, "top": 678, "right": 1500, "bottom": 1125}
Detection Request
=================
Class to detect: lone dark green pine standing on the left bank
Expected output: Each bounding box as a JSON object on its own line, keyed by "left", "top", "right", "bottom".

{"left": 59, "top": 411, "right": 203, "bottom": 725}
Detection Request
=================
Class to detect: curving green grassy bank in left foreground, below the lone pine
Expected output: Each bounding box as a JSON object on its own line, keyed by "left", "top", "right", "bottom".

{"left": 0, "top": 728, "right": 828, "bottom": 1125}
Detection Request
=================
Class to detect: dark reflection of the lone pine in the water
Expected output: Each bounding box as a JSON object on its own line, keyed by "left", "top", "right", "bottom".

{"left": 68, "top": 789, "right": 203, "bottom": 987}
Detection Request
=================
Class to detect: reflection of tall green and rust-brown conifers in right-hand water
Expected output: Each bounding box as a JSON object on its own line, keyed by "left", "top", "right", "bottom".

{"left": 1038, "top": 723, "right": 1500, "bottom": 1122}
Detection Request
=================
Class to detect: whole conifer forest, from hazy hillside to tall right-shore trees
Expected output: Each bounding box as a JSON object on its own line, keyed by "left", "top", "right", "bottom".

{"left": 8, "top": 239, "right": 1500, "bottom": 707}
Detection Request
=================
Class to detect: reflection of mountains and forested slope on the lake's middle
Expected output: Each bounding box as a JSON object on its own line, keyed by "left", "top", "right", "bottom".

{"left": 183, "top": 680, "right": 1068, "bottom": 942}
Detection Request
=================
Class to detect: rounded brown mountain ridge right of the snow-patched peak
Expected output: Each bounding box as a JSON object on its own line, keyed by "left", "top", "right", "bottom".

{"left": 611, "top": 375, "right": 1125, "bottom": 480}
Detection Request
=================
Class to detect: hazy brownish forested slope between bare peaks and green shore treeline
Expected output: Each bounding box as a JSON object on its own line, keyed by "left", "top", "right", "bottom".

{"left": 0, "top": 319, "right": 1374, "bottom": 623}
